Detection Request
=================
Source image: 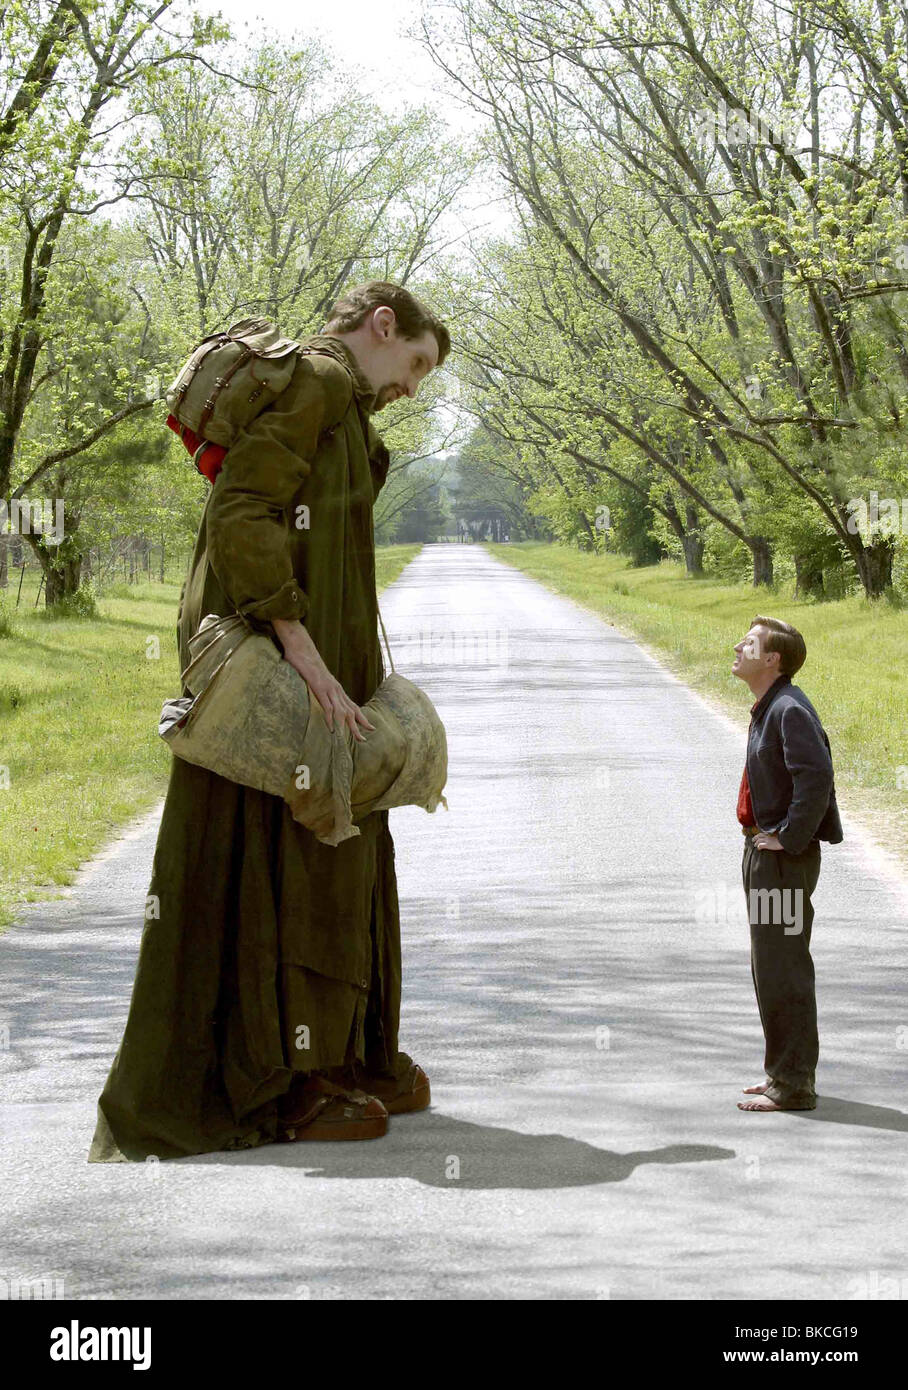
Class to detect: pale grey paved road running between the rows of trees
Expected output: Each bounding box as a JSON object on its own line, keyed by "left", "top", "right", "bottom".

{"left": 0, "top": 545, "right": 908, "bottom": 1300}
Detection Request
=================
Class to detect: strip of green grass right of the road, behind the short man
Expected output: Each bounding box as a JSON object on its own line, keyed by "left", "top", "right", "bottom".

{"left": 485, "top": 541, "right": 908, "bottom": 866}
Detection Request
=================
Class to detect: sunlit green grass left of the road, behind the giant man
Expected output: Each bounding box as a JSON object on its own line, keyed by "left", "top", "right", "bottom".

{"left": 0, "top": 545, "right": 420, "bottom": 929}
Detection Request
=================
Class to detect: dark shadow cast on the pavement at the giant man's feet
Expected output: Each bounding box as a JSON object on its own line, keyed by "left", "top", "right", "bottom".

{"left": 180, "top": 1112, "right": 736, "bottom": 1191}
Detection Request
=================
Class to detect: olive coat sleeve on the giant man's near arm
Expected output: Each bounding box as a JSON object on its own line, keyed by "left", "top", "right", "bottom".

{"left": 206, "top": 357, "right": 353, "bottom": 621}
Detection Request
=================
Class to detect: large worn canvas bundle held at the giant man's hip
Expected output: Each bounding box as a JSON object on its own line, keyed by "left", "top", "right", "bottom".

{"left": 159, "top": 613, "right": 448, "bottom": 845}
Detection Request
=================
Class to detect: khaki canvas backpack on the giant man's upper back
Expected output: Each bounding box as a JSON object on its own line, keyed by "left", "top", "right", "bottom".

{"left": 164, "top": 318, "right": 309, "bottom": 449}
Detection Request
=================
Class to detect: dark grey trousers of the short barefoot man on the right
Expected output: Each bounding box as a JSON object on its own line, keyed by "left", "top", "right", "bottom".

{"left": 741, "top": 835, "right": 820, "bottom": 1104}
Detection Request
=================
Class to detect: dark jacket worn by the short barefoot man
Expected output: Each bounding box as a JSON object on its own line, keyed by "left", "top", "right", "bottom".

{"left": 747, "top": 676, "right": 844, "bottom": 855}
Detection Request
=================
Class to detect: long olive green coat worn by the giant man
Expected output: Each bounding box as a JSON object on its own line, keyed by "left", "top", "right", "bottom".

{"left": 89, "top": 335, "right": 410, "bottom": 1162}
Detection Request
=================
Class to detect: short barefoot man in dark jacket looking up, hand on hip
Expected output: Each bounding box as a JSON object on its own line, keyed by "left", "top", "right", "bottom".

{"left": 731, "top": 617, "right": 843, "bottom": 1111}
